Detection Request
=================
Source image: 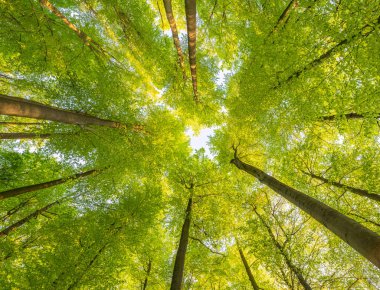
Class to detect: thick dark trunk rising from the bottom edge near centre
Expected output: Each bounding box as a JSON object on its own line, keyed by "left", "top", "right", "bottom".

{"left": 170, "top": 197, "right": 193, "bottom": 290}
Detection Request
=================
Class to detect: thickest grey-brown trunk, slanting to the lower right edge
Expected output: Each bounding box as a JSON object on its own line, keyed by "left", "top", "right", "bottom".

{"left": 231, "top": 156, "right": 380, "bottom": 268}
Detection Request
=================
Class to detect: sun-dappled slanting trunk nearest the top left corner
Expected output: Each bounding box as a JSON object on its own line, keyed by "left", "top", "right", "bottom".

{"left": 40, "top": 0, "right": 108, "bottom": 56}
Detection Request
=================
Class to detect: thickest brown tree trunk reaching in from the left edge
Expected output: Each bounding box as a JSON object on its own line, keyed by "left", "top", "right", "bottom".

{"left": 0, "top": 94, "right": 143, "bottom": 131}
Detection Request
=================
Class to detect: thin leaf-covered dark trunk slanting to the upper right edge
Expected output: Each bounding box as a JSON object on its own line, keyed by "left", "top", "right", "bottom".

{"left": 276, "top": 17, "right": 380, "bottom": 88}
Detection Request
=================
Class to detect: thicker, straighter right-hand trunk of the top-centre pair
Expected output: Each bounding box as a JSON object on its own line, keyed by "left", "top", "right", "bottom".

{"left": 185, "top": 0, "right": 199, "bottom": 102}
